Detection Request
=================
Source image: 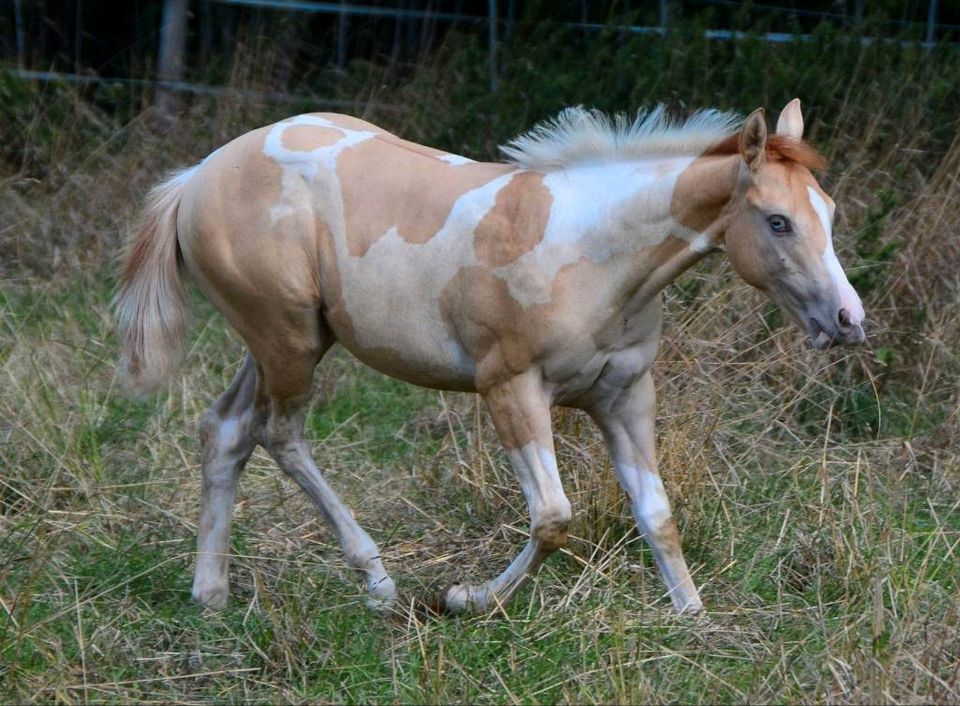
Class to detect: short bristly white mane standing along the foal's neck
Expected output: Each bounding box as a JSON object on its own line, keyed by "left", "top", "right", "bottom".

{"left": 500, "top": 104, "right": 742, "bottom": 171}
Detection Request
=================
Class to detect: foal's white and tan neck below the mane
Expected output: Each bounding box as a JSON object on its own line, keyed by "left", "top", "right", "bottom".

{"left": 547, "top": 156, "right": 739, "bottom": 308}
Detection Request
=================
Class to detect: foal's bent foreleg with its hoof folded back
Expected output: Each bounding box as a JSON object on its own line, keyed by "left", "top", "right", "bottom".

{"left": 444, "top": 371, "right": 570, "bottom": 612}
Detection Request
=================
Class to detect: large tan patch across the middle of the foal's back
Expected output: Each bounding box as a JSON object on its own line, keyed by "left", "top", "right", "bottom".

{"left": 337, "top": 139, "right": 517, "bottom": 257}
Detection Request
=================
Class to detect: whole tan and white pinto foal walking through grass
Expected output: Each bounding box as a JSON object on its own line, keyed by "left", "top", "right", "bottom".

{"left": 116, "top": 99, "right": 864, "bottom": 613}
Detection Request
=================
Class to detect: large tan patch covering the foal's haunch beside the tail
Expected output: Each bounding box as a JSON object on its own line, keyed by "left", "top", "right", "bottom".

{"left": 172, "top": 130, "right": 325, "bottom": 398}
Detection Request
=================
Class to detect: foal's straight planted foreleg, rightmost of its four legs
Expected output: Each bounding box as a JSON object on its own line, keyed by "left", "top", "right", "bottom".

{"left": 590, "top": 372, "right": 703, "bottom": 612}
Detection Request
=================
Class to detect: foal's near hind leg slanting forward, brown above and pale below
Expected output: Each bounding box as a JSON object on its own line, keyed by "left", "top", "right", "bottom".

{"left": 262, "top": 346, "right": 396, "bottom": 608}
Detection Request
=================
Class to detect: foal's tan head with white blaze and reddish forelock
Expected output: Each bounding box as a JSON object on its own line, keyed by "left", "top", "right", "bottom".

{"left": 724, "top": 99, "right": 864, "bottom": 348}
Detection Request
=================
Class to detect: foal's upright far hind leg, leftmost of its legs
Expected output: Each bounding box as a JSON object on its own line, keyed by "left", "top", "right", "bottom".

{"left": 193, "top": 354, "right": 262, "bottom": 608}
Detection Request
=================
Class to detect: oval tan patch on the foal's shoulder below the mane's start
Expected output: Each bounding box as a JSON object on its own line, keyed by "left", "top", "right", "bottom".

{"left": 473, "top": 172, "right": 553, "bottom": 267}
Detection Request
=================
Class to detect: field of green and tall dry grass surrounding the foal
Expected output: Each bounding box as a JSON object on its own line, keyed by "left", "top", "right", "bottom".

{"left": 0, "top": 24, "right": 960, "bottom": 703}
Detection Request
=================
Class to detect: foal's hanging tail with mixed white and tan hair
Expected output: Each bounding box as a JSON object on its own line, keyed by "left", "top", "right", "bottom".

{"left": 114, "top": 168, "right": 194, "bottom": 394}
